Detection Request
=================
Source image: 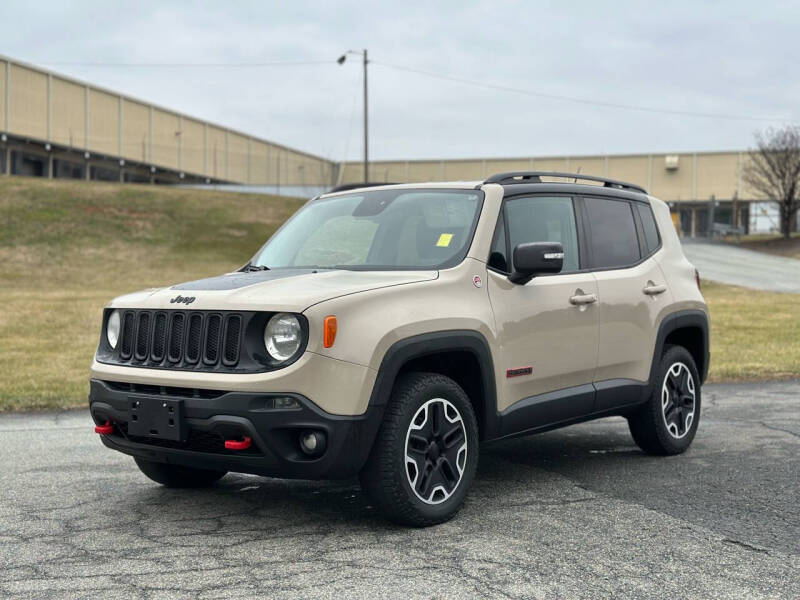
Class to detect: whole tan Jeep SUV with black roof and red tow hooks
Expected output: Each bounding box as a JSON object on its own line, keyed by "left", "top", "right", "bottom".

{"left": 89, "top": 172, "right": 709, "bottom": 525}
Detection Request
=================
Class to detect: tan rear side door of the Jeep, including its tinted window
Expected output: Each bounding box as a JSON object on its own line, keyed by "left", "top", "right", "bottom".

{"left": 583, "top": 197, "right": 670, "bottom": 410}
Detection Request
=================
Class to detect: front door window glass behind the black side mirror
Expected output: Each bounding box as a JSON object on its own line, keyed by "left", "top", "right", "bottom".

{"left": 506, "top": 196, "right": 578, "bottom": 273}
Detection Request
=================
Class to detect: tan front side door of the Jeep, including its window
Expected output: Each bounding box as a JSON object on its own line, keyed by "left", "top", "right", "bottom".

{"left": 488, "top": 196, "right": 598, "bottom": 429}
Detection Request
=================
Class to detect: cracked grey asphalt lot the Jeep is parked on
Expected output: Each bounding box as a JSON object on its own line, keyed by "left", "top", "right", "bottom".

{"left": 0, "top": 382, "right": 800, "bottom": 599}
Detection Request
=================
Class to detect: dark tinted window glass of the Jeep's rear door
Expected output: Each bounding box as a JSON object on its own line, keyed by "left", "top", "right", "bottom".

{"left": 585, "top": 198, "right": 641, "bottom": 268}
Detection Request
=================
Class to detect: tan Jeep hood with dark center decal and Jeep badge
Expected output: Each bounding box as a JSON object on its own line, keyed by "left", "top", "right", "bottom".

{"left": 111, "top": 269, "right": 439, "bottom": 312}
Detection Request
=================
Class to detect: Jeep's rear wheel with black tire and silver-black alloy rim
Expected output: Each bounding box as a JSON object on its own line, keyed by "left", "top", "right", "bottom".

{"left": 628, "top": 346, "right": 700, "bottom": 456}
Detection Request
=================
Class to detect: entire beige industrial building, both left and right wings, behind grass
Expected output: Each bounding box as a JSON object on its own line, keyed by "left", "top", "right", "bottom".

{"left": 0, "top": 55, "right": 784, "bottom": 236}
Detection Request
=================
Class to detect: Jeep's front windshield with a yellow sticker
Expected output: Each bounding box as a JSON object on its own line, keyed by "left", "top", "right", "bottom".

{"left": 251, "top": 189, "right": 483, "bottom": 270}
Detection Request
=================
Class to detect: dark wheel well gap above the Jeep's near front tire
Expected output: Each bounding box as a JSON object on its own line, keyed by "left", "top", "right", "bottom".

{"left": 397, "top": 350, "right": 486, "bottom": 439}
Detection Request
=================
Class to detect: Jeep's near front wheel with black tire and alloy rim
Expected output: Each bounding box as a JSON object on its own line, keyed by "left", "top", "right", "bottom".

{"left": 359, "top": 373, "right": 478, "bottom": 527}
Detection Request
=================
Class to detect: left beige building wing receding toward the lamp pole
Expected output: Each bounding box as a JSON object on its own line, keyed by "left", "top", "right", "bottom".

{"left": 0, "top": 56, "right": 335, "bottom": 185}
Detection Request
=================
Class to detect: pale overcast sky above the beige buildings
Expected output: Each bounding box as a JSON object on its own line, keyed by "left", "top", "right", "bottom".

{"left": 0, "top": 0, "right": 800, "bottom": 160}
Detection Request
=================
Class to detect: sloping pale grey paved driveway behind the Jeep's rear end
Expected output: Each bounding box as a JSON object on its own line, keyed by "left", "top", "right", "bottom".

{"left": 683, "top": 240, "right": 800, "bottom": 293}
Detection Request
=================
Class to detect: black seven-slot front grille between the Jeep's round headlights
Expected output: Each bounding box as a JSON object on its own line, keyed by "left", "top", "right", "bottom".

{"left": 109, "top": 310, "right": 245, "bottom": 370}
